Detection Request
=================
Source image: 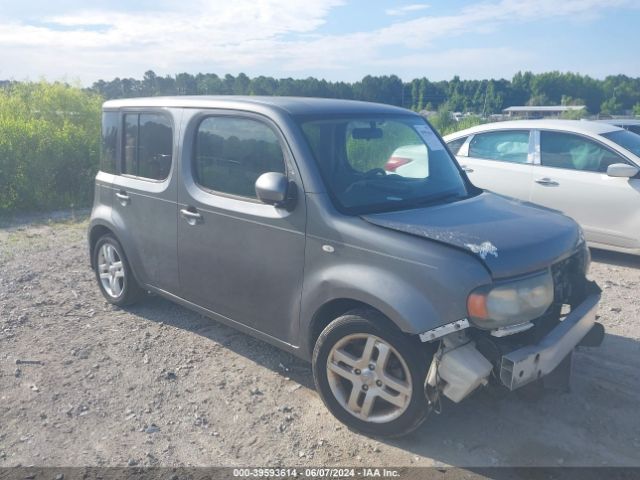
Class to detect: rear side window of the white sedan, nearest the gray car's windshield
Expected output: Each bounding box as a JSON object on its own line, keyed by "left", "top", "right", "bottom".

{"left": 469, "top": 130, "right": 529, "bottom": 163}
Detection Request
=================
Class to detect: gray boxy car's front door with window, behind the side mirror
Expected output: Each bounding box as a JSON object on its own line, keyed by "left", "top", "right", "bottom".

{"left": 178, "top": 112, "right": 306, "bottom": 343}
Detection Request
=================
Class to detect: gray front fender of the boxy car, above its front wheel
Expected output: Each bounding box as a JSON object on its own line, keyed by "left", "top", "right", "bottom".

{"left": 299, "top": 217, "right": 491, "bottom": 358}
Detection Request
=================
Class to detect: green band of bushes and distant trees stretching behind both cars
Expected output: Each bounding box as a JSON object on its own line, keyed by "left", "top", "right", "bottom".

{"left": 0, "top": 71, "right": 640, "bottom": 213}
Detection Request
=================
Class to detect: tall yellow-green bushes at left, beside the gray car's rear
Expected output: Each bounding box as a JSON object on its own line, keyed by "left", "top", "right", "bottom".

{"left": 0, "top": 82, "right": 102, "bottom": 213}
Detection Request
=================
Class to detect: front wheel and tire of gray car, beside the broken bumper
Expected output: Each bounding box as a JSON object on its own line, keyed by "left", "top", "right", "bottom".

{"left": 312, "top": 310, "right": 432, "bottom": 437}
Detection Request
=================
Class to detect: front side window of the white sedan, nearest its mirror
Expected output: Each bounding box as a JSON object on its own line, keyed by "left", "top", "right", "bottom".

{"left": 540, "top": 131, "right": 627, "bottom": 173}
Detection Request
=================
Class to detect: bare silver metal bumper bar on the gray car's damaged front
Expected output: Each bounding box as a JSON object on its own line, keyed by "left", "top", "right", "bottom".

{"left": 500, "top": 283, "right": 601, "bottom": 390}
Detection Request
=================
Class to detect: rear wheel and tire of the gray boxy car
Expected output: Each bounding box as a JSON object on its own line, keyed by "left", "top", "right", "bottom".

{"left": 93, "top": 234, "right": 145, "bottom": 307}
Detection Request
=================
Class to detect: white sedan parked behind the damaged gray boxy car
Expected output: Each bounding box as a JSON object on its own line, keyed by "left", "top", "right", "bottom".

{"left": 444, "top": 120, "right": 640, "bottom": 255}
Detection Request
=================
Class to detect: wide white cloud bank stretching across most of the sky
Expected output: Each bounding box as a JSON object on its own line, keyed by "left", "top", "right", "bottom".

{"left": 0, "top": 0, "right": 638, "bottom": 83}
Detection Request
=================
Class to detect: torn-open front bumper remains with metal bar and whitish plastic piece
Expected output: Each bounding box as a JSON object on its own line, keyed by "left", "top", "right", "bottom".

{"left": 428, "top": 282, "right": 604, "bottom": 402}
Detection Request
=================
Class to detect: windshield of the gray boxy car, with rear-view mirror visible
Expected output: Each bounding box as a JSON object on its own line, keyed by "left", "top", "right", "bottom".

{"left": 300, "top": 115, "right": 468, "bottom": 214}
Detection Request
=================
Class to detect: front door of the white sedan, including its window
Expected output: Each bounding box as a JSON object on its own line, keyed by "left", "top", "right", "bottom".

{"left": 531, "top": 130, "right": 640, "bottom": 248}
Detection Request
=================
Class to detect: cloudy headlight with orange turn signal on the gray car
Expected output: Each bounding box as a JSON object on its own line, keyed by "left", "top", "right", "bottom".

{"left": 467, "top": 271, "right": 553, "bottom": 329}
